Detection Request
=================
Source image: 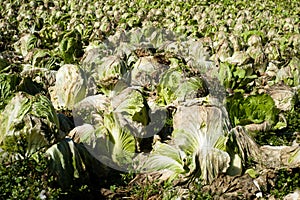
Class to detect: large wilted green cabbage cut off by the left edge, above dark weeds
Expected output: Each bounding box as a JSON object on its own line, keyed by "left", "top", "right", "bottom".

{"left": 0, "top": 92, "right": 60, "bottom": 157}
